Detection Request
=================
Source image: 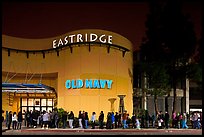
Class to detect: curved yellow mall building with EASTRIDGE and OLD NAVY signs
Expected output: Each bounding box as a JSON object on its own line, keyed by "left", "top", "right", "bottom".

{"left": 2, "top": 29, "right": 133, "bottom": 117}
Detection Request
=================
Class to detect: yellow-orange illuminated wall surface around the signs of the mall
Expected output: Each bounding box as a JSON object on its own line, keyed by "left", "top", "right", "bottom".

{"left": 2, "top": 29, "right": 133, "bottom": 118}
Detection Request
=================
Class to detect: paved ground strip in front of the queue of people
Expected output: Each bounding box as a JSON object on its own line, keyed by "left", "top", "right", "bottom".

{"left": 2, "top": 128, "right": 202, "bottom": 135}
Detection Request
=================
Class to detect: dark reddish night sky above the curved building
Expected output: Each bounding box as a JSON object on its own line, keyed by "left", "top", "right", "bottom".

{"left": 2, "top": 1, "right": 201, "bottom": 49}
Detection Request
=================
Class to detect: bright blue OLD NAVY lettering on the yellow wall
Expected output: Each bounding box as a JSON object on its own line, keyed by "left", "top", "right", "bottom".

{"left": 65, "top": 79, "right": 113, "bottom": 89}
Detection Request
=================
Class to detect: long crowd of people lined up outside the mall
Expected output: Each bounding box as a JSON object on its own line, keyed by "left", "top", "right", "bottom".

{"left": 2, "top": 109, "right": 202, "bottom": 130}
